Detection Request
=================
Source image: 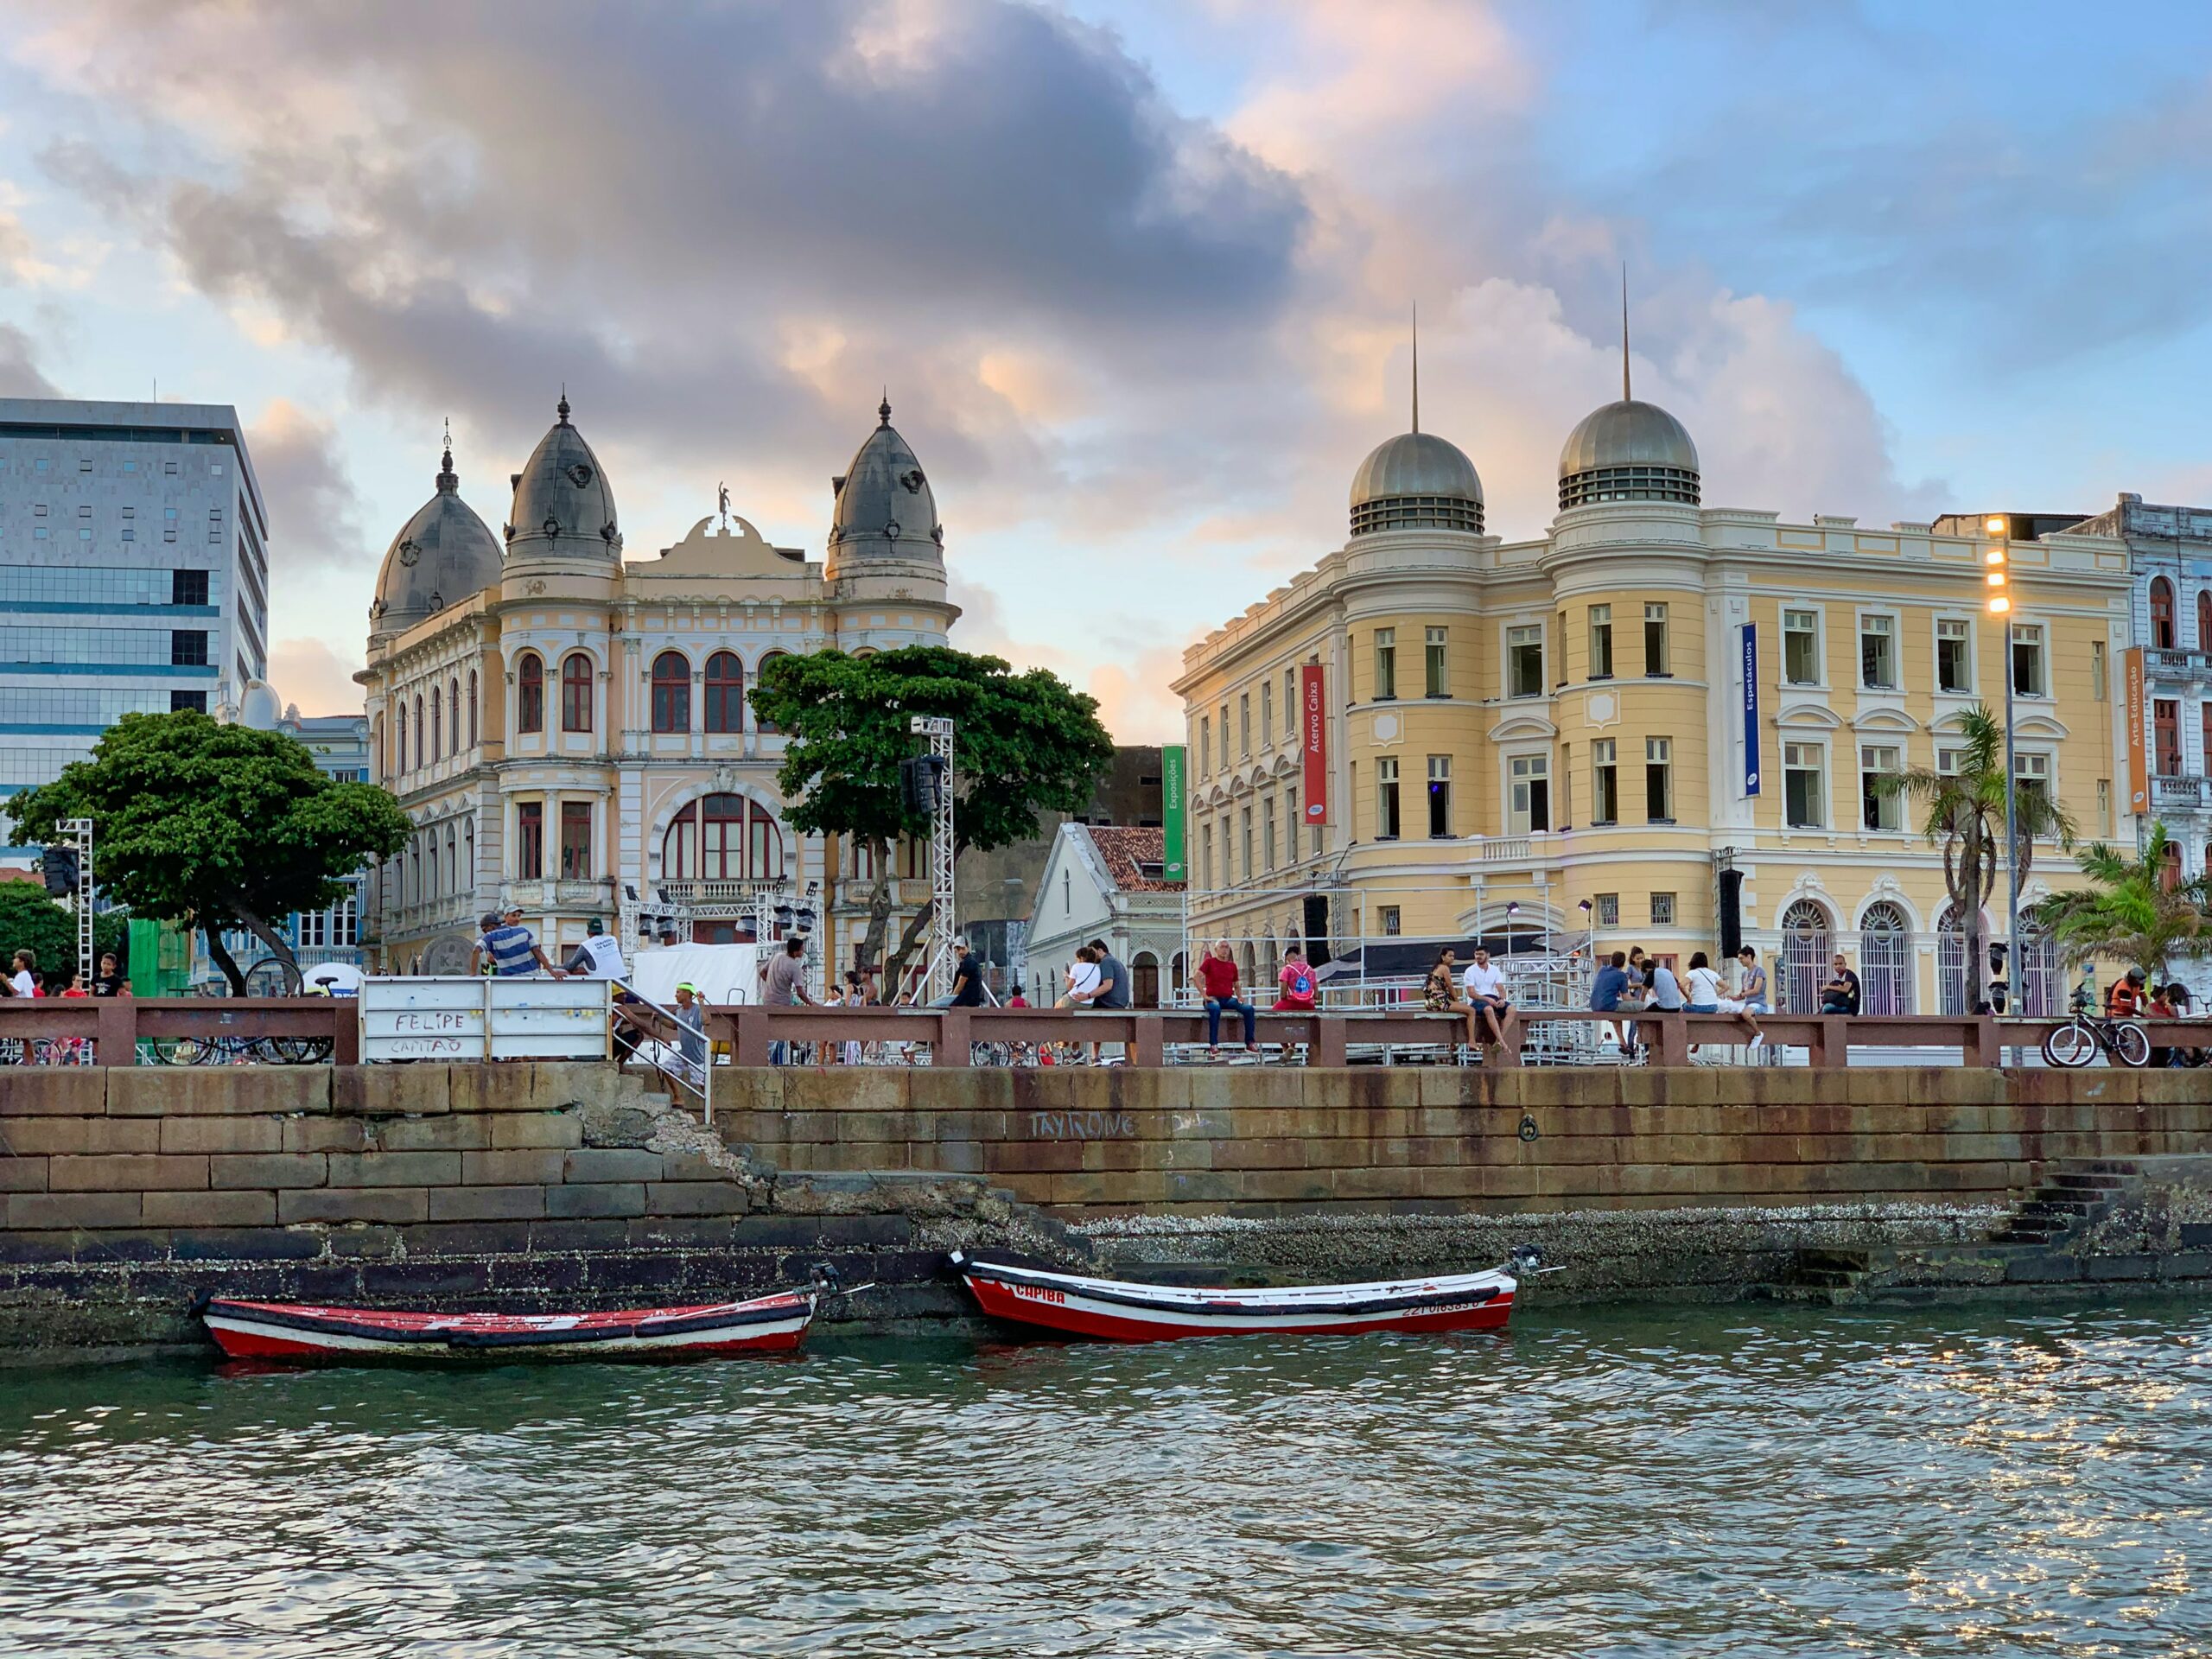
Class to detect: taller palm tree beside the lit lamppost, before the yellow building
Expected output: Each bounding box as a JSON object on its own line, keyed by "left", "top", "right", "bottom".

{"left": 1873, "top": 703, "right": 2075, "bottom": 1011}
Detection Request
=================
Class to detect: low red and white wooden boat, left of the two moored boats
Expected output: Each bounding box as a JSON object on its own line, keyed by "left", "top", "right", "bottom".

{"left": 201, "top": 1285, "right": 821, "bottom": 1360}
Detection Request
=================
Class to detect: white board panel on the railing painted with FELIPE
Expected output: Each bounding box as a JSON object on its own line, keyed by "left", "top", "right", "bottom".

{"left": 360, "top": 976, "right": 608, "bottom": 1062}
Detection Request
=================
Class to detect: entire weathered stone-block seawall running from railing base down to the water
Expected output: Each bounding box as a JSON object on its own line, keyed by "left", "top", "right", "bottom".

{"left": 0, "top": 1064, "right": 2212, "bottom": 1351}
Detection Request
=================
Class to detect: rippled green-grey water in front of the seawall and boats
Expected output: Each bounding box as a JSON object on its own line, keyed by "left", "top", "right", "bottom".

{"left": 0, "top": 1300, "right": 2212, "bottom": 1659}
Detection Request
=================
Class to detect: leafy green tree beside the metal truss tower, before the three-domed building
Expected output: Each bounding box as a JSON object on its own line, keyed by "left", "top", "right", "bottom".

{"left": 752, "top": 646, "right": 1113, "bottom": 991}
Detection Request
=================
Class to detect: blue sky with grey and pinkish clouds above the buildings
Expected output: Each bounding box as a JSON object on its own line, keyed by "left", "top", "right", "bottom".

{"left": 0, "top": 0, "right": 2212, "bottom": 743}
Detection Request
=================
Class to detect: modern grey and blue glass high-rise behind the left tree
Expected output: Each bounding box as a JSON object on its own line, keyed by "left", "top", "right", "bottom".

{"left": 0, "top": 398, "right": 270, "bottom": 827}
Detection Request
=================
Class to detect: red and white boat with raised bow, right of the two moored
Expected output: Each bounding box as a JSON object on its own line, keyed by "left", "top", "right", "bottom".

{"left": 951, "top": 1249, "right": 1537, "bottom": 1343}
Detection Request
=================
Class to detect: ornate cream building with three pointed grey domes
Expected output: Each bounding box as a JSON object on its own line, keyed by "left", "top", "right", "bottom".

{"left": 356, "top": 396, "right": 960, "bottom": 973}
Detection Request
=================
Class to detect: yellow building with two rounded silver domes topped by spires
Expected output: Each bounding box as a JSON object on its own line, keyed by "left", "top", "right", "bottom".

{"left": 1174, "top": 385, "right": 2130, "bottom": 1013}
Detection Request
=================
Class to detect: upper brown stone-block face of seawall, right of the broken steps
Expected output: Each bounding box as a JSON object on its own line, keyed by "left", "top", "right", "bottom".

{"left": 716, "top": 1066, "right": 2212, "bottom": 1219}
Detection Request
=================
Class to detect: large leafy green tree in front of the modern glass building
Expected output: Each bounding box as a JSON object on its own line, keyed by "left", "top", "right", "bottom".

{"left": 7, "top": 710, "right": 410, "bottom": 995}
